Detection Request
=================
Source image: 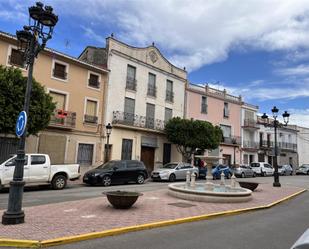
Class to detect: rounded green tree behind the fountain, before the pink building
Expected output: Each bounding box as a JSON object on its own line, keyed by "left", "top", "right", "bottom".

{"left": 165, "top": 117, "right": 222, "bottom": 160}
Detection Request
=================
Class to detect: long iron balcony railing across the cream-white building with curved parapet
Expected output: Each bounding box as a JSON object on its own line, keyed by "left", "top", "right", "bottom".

{"left": 113, "top": 111, "right": 165, "bottom": 131}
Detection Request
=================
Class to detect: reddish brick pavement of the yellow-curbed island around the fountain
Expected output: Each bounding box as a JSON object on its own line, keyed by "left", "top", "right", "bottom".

{"left": 0, "top": 184, "right": 301, "bottom": 241}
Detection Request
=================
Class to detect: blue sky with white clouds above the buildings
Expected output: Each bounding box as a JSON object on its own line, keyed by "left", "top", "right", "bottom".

{"left": 0, "top": 0, "right": 309, "bottom": 127}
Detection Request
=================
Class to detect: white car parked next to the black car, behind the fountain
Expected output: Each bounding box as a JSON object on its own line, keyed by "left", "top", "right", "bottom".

{"left": 151, "top": 162, "right": 198, "bottom": 182}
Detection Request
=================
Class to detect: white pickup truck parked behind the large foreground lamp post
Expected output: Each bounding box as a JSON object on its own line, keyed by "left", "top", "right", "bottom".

{"left": 0, "top": 154, "right": 80, "bottom": 189}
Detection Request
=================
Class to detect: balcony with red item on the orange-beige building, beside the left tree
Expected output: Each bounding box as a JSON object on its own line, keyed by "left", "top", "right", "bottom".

{"left": 48, "top": 109, "right": 76, "bottom": 129}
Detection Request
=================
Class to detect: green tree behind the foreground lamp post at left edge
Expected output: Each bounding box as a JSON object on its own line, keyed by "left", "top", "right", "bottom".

{"left": 0, "top": 66, "right": 56, "bottom": 135}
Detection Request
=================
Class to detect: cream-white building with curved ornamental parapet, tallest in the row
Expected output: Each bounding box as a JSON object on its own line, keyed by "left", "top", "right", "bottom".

{"left": 79, "top": 37, "right": 187, "bottom": 172}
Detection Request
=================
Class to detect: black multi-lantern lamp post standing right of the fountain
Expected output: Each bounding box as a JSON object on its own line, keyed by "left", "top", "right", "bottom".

{"left": 262, "top": 106, "right": 290, "bottom": 187}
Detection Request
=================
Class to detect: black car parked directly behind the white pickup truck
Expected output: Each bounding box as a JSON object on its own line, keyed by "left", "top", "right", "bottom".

{"left": 83, "top": 160, "right": 148, "bottom": 186}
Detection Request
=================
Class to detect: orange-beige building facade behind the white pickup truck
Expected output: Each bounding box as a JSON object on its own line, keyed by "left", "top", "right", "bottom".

{"left": 0, "top": 32, "right": 108, "bottom": 165}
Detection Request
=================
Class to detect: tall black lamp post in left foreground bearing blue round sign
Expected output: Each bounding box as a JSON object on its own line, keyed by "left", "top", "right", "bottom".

{"left": 2, "top": 2, "right": 58, "bottom": 225}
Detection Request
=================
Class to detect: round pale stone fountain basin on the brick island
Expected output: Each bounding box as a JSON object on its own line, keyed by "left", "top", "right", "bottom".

{"left": 168, "top": 183, "right": 252, "bottom": 203}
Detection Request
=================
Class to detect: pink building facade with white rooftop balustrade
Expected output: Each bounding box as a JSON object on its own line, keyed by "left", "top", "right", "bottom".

{"left": 185, "top": 84, "right": 243, "bottom": 166}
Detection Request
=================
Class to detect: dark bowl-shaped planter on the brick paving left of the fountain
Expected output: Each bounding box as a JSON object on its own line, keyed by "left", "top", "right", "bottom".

{"left": 103, "top": 190, "right": 143, "bottom": 209}
